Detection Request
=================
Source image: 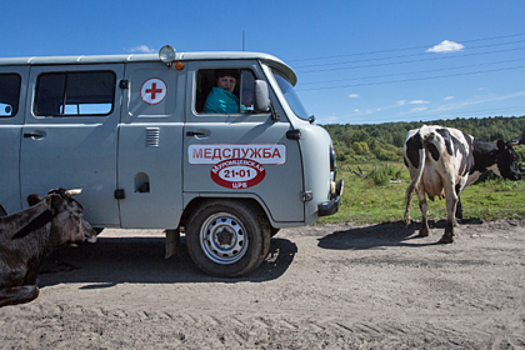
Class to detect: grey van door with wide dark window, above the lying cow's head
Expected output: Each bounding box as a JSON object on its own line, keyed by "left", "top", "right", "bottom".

{"left": 20, "top": 64, "right": 124, "bottom": 227}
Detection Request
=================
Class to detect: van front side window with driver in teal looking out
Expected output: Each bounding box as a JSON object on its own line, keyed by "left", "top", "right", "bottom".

{"left": 195, "top": 68, "right": 255, "bottom": 114}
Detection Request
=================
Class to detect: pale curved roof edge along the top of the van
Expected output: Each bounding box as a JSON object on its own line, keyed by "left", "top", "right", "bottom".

{"left": 0, "top": 51, "right": 297, "bottom": 85}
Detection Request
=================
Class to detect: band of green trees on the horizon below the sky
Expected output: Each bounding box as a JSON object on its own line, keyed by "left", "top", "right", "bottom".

{"left": 320, "top": 116, "right": 525, "bottom": 164}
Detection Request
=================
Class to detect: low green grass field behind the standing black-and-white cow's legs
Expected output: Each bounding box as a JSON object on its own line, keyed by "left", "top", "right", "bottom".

{"left": 318, "top": 162, "right": 525, "bottom": 224}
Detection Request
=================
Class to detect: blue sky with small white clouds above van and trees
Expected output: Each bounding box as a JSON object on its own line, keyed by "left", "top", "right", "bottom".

{"left": 0, "top": 0, "right": 525, "bottom": 124}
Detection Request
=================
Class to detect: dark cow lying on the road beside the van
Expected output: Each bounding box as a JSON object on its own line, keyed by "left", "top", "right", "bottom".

{"left": 0, "top": 189, "right": 97, "bottom": 307}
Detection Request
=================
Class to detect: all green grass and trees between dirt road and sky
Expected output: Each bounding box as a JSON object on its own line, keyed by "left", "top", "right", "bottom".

{"left": 319, "top": 117, "right": 525, "bottom": 224}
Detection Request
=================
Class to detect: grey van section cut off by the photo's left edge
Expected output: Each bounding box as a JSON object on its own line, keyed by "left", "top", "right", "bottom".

{"left": 0, "top": 66, "right": 29, "bottom": 214}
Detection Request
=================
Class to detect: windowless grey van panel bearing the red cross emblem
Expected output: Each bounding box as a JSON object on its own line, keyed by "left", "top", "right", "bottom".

{"left": 118, "top": 61, "right": 186, "bottom": 228}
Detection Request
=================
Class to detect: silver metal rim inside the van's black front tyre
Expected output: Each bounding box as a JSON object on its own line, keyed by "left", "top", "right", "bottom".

{"left": 200, "top": 213, "right": 248, "bottom": 265}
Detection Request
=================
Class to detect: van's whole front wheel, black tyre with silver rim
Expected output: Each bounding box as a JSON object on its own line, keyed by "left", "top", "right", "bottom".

{"left": 186, "top": 200, "right": 271, "bottom": 277}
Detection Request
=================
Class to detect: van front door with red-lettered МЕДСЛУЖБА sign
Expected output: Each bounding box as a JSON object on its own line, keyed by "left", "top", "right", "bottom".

{"left": 184, "top": 60, "right": 304, "bottom": 223}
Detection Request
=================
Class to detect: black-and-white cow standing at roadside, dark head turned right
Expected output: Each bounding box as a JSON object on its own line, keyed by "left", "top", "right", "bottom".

{"left": 404, "top": 125, "right": 521, "bottom": 243}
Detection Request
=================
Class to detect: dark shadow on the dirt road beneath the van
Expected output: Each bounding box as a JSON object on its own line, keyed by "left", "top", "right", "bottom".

{"left": 38, "top": 237, "right": 297, "bottom": 289}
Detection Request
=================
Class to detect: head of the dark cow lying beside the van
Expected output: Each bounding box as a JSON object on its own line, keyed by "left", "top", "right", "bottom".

{"left": 27, "top": 188, "right": 97, "bottom": 245}
